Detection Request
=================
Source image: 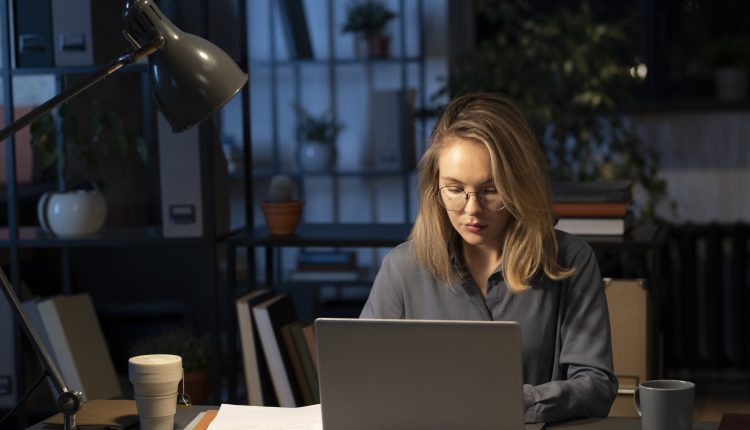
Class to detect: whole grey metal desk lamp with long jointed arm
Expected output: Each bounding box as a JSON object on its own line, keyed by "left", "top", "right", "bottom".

{"left": 0, "top": 0, "right": 247, "bottom": 430}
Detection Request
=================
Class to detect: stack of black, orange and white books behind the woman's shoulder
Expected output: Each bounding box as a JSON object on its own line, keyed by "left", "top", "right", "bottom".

{"left": 552, "top": 181, "right": 633, "bottom": 236}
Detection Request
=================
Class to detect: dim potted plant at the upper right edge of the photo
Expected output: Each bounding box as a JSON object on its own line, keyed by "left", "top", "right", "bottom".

{"left": 705, "top": 36, "right": 750, "bottom": 101}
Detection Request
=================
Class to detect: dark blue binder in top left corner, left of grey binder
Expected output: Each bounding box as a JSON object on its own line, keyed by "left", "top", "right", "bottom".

{"left": 13, "top": 0, "right": 54, "bottom": 67}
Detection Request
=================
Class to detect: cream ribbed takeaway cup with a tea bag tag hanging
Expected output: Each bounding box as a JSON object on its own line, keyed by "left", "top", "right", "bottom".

{"left": 128, "top": 354, "right": 182, "bottom": 430}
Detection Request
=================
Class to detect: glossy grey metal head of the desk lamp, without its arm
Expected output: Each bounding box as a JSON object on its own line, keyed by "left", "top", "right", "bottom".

{"left": 123, "top": 0, "right": 247, "bottom": 132}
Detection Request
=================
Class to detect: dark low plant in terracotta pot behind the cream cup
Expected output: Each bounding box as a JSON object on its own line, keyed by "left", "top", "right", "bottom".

{"left": 128, "top": 327, "right": 211, "bottom": 405}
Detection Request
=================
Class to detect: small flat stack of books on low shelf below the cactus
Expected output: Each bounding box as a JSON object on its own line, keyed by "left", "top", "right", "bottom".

{"left": 289, "top": 250, "right": 361, "bottom": 282}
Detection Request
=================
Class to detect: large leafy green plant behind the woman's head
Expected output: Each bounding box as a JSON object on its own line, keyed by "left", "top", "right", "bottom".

{"left": 436, "top": 0, "right": 666, "bottom": 220}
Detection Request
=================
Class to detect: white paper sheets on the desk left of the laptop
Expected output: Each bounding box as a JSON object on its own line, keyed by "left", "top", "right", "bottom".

{"left": 208, "top": 404, "right": 323, "bottom": 430}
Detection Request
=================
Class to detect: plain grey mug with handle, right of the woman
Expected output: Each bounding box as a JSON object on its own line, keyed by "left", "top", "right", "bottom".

{"left": 634, "top": 379, "right": 695, "bottom": 430}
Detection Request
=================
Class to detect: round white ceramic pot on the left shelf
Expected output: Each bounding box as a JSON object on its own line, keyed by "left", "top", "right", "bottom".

{"left": 37, "top": 190, "right": 107, "bottom": 236}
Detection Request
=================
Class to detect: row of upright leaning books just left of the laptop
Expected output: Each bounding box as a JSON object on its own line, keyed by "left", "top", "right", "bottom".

{"left": 236, "top": 289, "right": 320, "bottom": 408}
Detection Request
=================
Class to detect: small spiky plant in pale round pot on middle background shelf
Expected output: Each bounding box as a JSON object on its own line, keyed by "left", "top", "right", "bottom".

{"left": 294, "top": 105, "right": 343, "bottom": 172}
